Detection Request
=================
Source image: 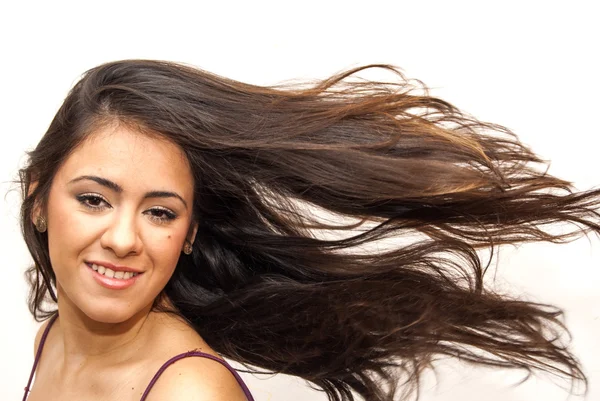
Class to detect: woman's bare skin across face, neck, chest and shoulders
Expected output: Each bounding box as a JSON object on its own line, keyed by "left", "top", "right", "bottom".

{"left": 28, "top": 124, "right": 245, "bottom": 401}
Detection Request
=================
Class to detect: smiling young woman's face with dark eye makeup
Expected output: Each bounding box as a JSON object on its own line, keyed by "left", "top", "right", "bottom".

{"left": 47, "top": 126, "right": 195, "bottom": 323}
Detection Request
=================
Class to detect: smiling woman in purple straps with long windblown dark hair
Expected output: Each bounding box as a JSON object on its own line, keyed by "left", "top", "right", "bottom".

{"left": 21, "top": 60, "right": 600, "bottom": 401}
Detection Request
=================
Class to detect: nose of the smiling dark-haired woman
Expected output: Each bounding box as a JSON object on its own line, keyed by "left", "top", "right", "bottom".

{"left": 100, "top": 211, "right": 142, "bottom": 258}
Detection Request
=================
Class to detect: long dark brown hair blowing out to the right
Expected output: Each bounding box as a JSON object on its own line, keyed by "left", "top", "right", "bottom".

{"left": 20, "top": 60, "right": 600, "bottom": 401}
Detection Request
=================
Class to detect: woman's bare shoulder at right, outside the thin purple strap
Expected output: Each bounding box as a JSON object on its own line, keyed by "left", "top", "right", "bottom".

{"left": 147, "top": 356, "right": 247, "bottom": 401}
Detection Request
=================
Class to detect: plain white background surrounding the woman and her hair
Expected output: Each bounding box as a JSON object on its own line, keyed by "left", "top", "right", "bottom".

{"left": 0, "top": 0, "right": 600, "bottom": 401}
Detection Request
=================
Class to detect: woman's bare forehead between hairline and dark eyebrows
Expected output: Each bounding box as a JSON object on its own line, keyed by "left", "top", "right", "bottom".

{"left": 57, "top": 125, "right": 193, "bottom": 196}
